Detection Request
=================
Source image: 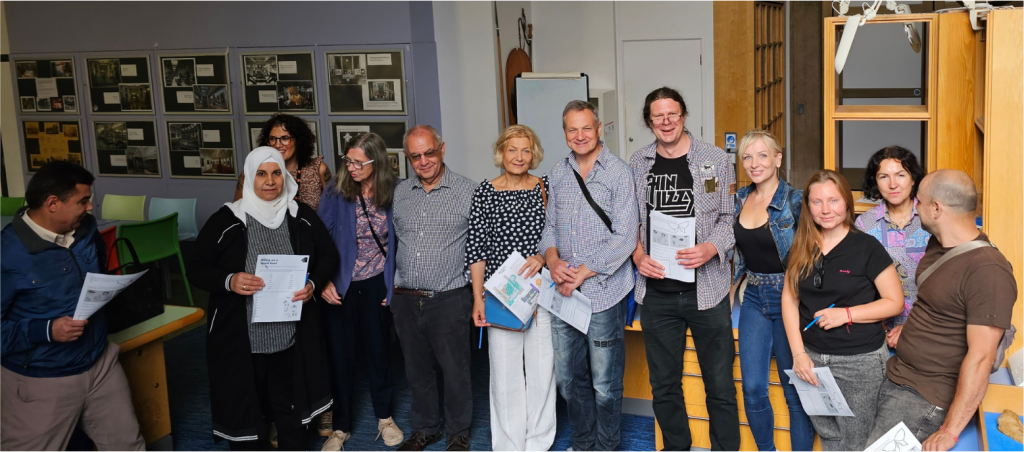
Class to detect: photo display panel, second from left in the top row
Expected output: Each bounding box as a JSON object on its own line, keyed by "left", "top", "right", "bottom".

{"left": 86, "top": 55, "right": 153, "bottom": 115}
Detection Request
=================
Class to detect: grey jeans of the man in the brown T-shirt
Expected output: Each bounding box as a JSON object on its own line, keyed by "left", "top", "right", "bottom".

{"left": 867, "top": 378, "right": 946, "bottom": 445}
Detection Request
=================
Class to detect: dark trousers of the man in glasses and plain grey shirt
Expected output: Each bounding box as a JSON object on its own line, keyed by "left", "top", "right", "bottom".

{"left": 391, "top": 287, "right": 473, "bottom": 438}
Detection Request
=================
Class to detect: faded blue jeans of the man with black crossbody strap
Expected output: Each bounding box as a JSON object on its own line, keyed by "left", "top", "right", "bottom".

{"left": 551, "top": 299, "right": 626, "bottom": 452}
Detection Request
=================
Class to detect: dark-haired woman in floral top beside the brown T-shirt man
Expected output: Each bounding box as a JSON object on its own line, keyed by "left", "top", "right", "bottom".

{"left": 855, "top": 146, "right": 932, "bottom": 347}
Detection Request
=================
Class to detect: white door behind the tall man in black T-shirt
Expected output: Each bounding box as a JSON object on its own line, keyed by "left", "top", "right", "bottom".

{"left": 623, "top": 39, "right": 703, "bottom": 161}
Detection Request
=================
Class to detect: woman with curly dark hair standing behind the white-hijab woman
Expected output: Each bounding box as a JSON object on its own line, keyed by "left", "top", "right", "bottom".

{"left": 234, "top": 113, "right": 331, "bottom": 210}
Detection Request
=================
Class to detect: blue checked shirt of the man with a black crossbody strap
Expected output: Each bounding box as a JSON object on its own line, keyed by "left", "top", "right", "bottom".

{"left": 538, "top": 142, "right": 638, "bottom": 313}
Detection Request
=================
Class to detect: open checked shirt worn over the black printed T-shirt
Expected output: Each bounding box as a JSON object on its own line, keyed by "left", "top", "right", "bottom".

{"left": 630, "top": 132, "right": 736, "bottom": 311}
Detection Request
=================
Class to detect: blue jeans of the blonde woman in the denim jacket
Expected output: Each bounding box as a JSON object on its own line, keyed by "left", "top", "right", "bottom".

{"left": 739, "top": 274, "right": 814, "bottom": 451}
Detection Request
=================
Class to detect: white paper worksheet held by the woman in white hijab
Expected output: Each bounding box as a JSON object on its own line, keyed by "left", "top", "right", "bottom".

{"left": 253, "top": 254, "right": 309, "bottom": 322}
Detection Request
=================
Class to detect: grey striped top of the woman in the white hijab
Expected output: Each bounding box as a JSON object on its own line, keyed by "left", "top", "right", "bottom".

{"left": 246, "top": 215, "right": 301, "bottom": 354}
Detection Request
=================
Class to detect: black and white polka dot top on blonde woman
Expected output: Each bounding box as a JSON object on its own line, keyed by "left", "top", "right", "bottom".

{"left": 466, "top": 176, "right": 551, "bottom": 281}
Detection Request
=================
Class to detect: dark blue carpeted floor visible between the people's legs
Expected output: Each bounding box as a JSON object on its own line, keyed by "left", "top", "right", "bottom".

{"left": 164, "top": 321, "right": 654, "bottom": 452}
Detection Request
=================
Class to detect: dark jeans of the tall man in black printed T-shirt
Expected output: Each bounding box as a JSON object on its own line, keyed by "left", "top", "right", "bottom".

{"left": 640, "top": 288, "right": 739, "bottom": 452}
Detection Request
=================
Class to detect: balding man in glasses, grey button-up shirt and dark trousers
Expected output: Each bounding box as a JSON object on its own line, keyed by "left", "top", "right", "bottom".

{"left": 391, "top": 125, "right": 477, "bottom": 452}
